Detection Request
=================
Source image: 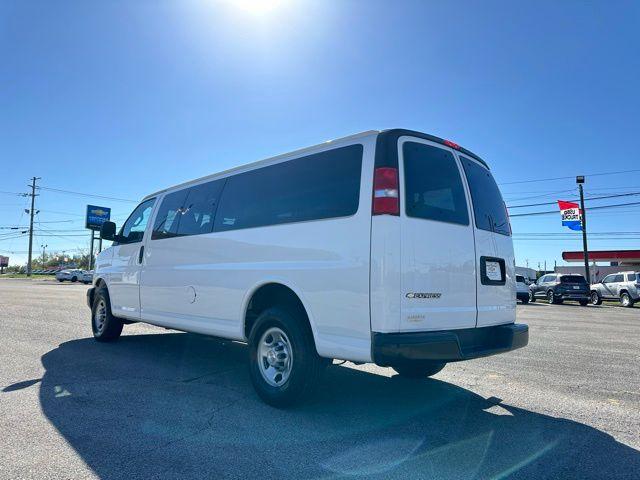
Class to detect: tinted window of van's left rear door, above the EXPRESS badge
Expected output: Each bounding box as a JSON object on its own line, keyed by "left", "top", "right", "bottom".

{"left": 402, "top": 142, "right": 469, "bottom": 225}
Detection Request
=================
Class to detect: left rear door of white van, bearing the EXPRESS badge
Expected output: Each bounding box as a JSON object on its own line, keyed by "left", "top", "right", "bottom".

{"left": 398, "top": 136, "right": 476, "bottom": 331}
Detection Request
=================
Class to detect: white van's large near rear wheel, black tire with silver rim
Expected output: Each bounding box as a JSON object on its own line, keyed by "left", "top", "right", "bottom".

{"left": 249, "top": 307, "right": 322, "bottom": 408}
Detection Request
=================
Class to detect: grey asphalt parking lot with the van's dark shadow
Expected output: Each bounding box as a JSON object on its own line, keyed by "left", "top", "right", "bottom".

{"left": 0, "top": 279, "right": 640, "bottom": 480}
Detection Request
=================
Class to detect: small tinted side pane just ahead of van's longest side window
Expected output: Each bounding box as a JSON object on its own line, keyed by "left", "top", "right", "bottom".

{"left": 178, "top": 180, "right": 225, "bottom": 235}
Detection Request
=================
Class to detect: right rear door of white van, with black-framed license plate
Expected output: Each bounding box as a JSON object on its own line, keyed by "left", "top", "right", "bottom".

{"left": 459, "top": 154, "right": 516, "bottom": 327}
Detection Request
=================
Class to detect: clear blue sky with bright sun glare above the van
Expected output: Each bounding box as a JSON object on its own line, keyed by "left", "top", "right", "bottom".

{"left": 0, "top": 0, "right": 640, "bottom": 266}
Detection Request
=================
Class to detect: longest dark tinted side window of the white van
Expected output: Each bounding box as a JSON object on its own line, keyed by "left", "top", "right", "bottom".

{"left": 214, "top": 145, "right": 363, "bottom": 231}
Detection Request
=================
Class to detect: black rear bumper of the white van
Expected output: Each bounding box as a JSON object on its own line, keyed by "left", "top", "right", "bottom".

{"left": 373, "top": 323, "right": 529, "bottom": 367}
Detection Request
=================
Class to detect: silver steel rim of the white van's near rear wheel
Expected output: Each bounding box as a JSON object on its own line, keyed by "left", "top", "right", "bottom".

{"left": 258, "top": 327, "right": 293, "bottom": 387}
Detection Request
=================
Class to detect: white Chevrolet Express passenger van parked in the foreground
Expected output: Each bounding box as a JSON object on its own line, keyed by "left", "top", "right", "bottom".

{"left": 87, "top": 129, "right": 528, "bottom": 406}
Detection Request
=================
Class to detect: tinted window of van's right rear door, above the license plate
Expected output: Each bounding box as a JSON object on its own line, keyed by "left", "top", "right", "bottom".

{"left": 460, "top": 155, "right": 511, "bottom": 236}
